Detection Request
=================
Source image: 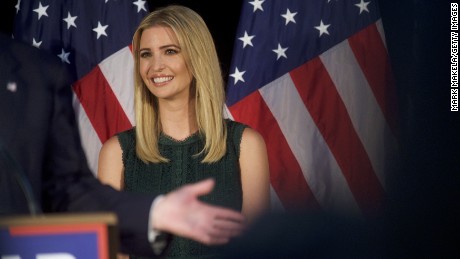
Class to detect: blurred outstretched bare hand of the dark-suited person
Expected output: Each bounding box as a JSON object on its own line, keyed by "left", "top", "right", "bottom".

{"left": 152, "top": 179, "right": 245, "bottom": 245}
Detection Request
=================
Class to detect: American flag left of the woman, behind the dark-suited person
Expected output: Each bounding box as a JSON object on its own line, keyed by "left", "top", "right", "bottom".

{"left": 14, "top": 0, "right": 148, "bottom": 173}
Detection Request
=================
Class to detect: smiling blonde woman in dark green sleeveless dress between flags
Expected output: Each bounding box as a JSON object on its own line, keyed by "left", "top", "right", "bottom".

{"left": 98, "top": 6, "right": 269, "bottom": 257}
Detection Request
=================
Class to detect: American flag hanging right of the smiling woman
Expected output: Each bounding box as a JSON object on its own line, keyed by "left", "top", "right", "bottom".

{"left": 226, "top": 0, "right": 398, "bottom": 216}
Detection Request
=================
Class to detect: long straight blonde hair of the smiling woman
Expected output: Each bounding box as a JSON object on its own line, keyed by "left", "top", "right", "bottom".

{"left": 132, "top": 5, "right": 227, "bottom": 163}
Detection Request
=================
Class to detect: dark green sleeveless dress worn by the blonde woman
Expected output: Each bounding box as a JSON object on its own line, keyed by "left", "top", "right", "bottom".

{"left": 117, "top": 120, "right": 247, "bottom": 258}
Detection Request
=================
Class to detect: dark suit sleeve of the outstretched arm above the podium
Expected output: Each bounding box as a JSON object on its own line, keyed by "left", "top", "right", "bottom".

{"left": 44, "top": 49, "right": 158, "bottom": 256}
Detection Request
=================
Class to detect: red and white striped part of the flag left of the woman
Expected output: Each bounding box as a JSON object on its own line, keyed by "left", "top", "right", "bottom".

{"left": 73, "top": 46, "right": 134, "bottom": 174}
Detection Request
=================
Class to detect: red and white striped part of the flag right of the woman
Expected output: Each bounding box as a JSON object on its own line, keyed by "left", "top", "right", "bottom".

{"left": 228, "top": 21, "right": 397, "bottom": 215}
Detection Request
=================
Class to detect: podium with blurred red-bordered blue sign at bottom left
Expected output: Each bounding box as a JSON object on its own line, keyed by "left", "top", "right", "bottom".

{"left": 0, "top": 213, "right": 119, "bottom": 259}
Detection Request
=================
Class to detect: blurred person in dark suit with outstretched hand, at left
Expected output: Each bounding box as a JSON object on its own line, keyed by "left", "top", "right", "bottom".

{"left": 0, "top": 34, "right": 244, "bottom": 256}
